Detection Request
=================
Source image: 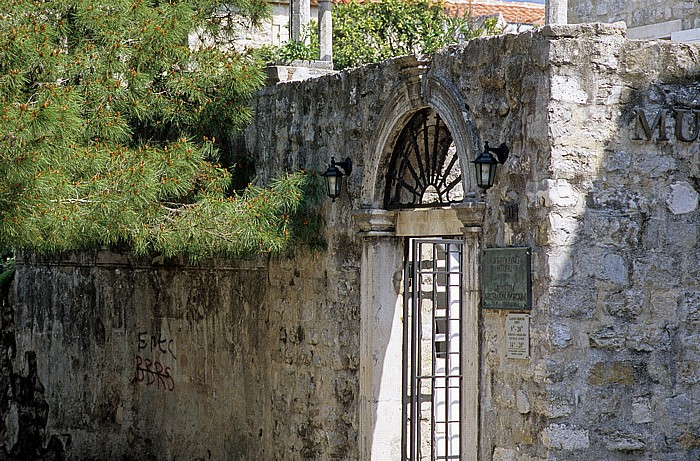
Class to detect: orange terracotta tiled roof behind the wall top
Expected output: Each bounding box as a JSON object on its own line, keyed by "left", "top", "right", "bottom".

{"left": 445, "top": 0, "right": 544, "bottom": 24}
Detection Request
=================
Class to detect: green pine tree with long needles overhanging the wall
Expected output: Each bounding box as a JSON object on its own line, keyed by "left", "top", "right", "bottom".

{"left": 0, "top": 0, "right": 322, "bottom": 259}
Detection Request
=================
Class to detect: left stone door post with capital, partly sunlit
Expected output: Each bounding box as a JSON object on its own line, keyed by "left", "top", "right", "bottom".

{"left": 354, "top": 210, "right": 403, "bottom": 461}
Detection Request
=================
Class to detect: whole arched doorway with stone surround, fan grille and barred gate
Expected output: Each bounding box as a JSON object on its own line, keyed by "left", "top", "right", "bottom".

{"left": 355, "top": 75, "right": 484, "bottom": 461}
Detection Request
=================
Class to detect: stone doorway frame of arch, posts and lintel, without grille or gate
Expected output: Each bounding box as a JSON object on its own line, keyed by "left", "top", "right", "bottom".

{"left": 353, "top": 66, "right": 485, "bottom": 461}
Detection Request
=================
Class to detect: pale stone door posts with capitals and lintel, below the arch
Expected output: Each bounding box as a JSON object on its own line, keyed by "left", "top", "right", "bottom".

{"left": 353, "top": 205, "right": 485, "bottom": 461}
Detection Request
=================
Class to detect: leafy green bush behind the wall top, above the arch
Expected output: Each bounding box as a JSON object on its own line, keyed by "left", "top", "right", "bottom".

{"left": 333, "top": 0, "right": 496, "bottom": 69}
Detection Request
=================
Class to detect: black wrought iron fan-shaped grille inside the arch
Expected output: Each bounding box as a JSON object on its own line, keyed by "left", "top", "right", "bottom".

{"left": 384, "top": 108, "right": 464, "bottom": 209}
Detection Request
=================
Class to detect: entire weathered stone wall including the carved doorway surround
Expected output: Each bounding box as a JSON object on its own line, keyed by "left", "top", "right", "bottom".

{"left": 2, "top": 25, "right": 700, "bottom": 461}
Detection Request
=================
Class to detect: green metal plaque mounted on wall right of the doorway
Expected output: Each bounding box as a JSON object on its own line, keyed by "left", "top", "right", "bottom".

{"left": 481, "top": 248, "right": 532, "bottom": 311}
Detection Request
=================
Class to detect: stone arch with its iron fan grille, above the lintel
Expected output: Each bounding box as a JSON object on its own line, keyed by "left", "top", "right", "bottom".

{"left": 362, "top": 72, "right": 481, "bottom": 209}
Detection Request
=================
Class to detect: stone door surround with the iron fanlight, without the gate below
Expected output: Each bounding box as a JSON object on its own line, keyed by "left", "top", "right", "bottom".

{"left": 353, "top": 66, "right": 485, "bottom": 461}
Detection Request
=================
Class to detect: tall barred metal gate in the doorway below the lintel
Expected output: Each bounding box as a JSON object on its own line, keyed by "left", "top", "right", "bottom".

{"left": 402, "top": 239, "right": 463, "bottom": 461}
